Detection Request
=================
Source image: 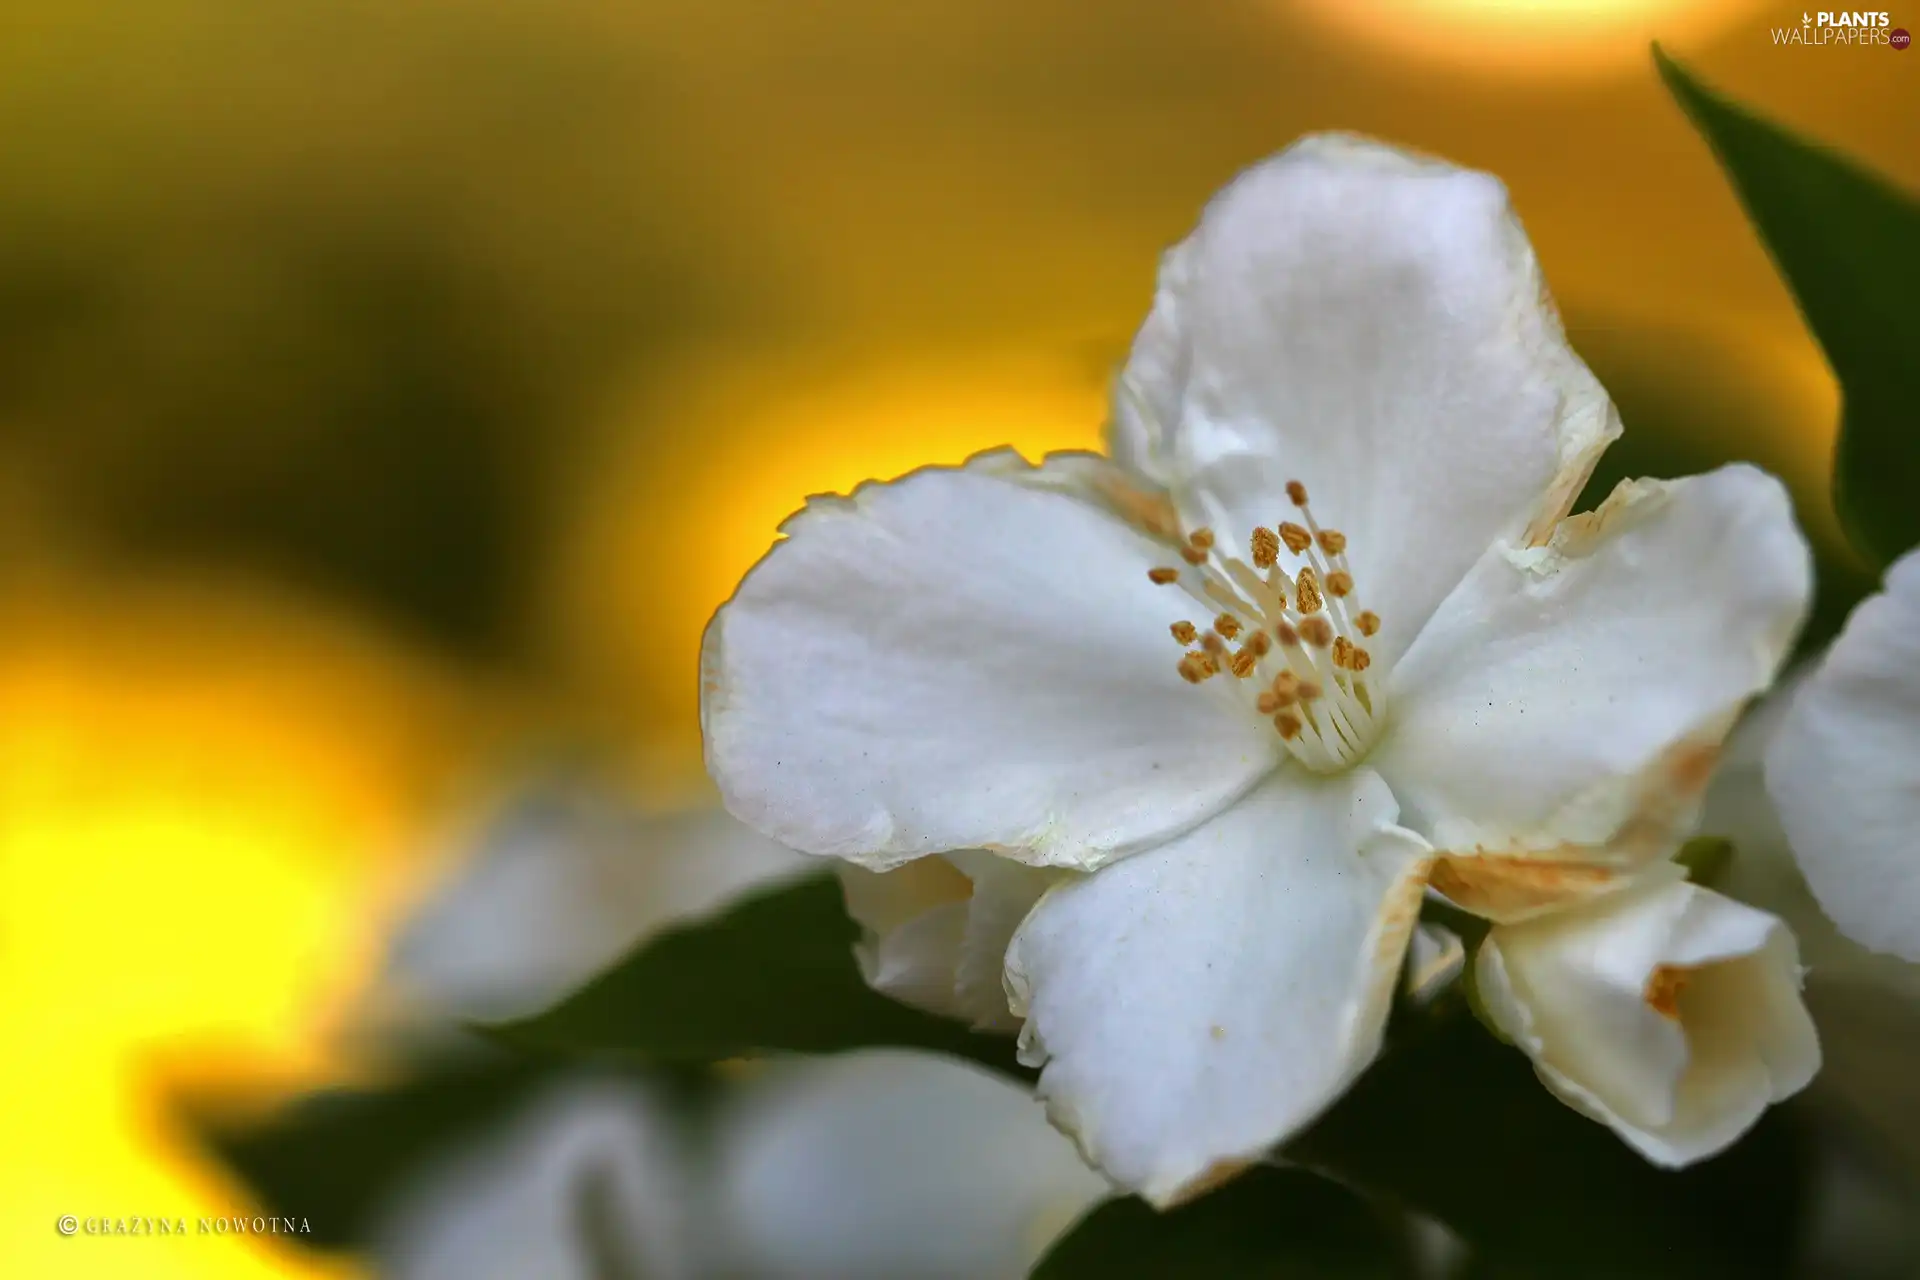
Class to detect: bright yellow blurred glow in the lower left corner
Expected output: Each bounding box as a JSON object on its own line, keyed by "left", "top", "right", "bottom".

{"left": 0, "top": 583, "right": 510, "bottom": 1280}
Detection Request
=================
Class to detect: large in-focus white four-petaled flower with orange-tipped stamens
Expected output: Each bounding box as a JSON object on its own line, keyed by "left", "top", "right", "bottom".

{"left": 701, "top": 136, "right": 1811, "bottom": 1203}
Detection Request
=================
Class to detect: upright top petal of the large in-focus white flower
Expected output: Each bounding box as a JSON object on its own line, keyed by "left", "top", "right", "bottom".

{"left": 1110, "top": 134, "right": 1620, "bottom": 656}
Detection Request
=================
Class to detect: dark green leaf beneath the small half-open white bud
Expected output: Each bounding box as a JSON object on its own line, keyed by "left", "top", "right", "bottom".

{"left": 1288, "top": 1017, "right": 1807, "bottom": 1280}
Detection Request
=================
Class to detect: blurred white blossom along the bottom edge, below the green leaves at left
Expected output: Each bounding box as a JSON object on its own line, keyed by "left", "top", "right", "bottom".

{"left": 374, "top": 1050, "right": 1110, "bottom": 1280}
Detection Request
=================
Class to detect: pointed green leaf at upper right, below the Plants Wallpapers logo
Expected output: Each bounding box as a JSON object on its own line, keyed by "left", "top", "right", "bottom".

{"left": 1653, "top": 46, "right": 1920, "bottom": 564}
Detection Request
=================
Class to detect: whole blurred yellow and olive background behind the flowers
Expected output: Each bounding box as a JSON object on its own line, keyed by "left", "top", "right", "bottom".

{"left": 0, "top": 0, "right": 1920, "bottom": 1276}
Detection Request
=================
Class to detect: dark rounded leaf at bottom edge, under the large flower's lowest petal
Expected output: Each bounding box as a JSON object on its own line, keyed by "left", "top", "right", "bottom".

{"left": 1033, "top": 1169, "right": 1411, "bottom": 1280}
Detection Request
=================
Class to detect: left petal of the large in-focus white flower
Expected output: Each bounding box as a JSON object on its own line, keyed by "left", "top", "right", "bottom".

{"left": 701, "top": 455, "right": 1279, "bottom": 869}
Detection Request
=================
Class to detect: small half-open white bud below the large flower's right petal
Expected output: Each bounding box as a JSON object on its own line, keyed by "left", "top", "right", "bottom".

{"left": 1475, "top": 867, "right": 1820, "bottom": 1167}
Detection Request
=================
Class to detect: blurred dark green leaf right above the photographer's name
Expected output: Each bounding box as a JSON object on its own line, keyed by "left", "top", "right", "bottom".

{"left": 182, "top": 1054, "right": 551, "bottom": 1249}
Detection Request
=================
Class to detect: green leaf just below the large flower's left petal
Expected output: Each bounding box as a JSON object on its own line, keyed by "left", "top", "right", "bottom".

{"left": 484, "top": 877, "right": 1021, "bottom": 1075}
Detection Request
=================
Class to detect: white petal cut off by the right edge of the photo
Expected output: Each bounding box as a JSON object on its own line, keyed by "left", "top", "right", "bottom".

{"left": 1766, "top": 551, "right": 1920, "bottom": 960}
